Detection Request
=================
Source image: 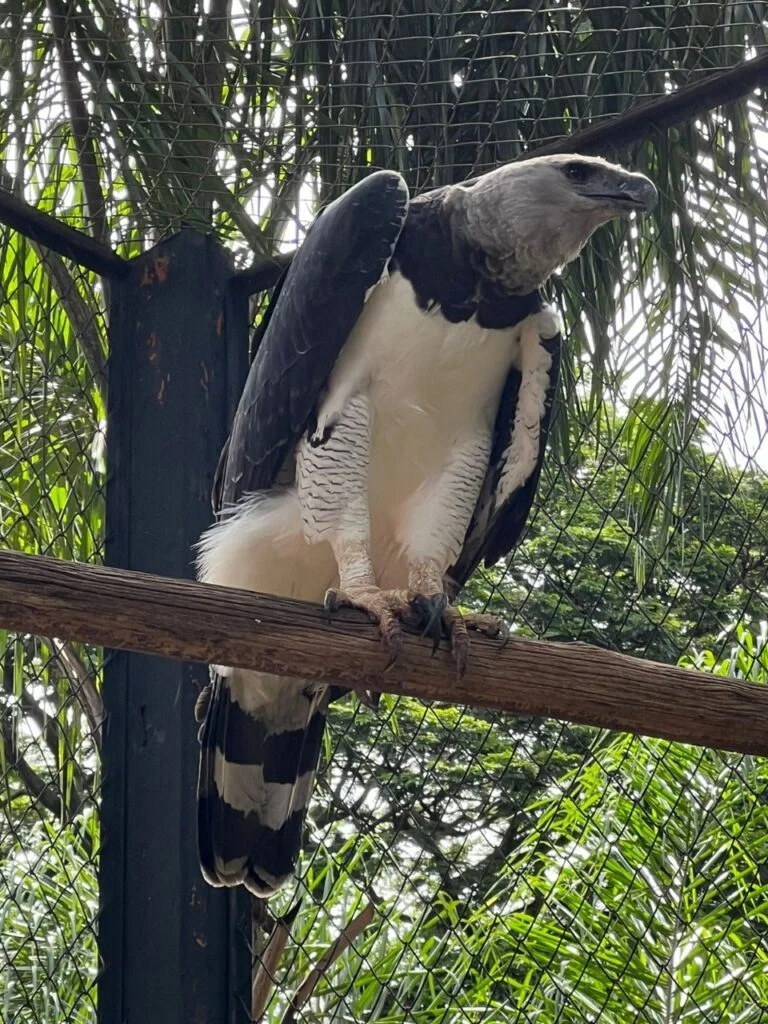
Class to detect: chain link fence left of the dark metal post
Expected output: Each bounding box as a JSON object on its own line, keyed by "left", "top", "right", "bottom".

{"left": 0, "top": 243, "right": 104, "bottom": 1022}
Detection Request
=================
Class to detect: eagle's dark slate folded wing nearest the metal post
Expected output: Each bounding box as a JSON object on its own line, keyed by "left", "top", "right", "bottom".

{"left": 214, "top": 171, "right": 409, "bottom": 511}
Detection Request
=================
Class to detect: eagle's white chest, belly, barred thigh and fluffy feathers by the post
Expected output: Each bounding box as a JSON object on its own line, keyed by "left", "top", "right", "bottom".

{"left": 199, "top": 273, "right": 538, "bottom": 601}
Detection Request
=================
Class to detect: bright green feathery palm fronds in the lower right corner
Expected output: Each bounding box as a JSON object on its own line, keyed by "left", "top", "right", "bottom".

{"left": 485, "top": 628, "right": 768, "bottom": 1024}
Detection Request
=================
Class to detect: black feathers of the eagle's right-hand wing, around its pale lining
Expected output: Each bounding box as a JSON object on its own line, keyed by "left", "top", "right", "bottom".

{"left": 447, "top": 334, "right": 562, "bottom": 589}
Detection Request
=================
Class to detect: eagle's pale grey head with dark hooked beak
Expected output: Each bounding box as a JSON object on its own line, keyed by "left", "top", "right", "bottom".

{"left": 454, "top": 154, "right": 657, "bottom": 295}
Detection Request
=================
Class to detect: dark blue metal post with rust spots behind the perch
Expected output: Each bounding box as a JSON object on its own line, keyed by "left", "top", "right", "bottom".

{"left": 98, "top": 230, "right": 250, "bottom": 1024}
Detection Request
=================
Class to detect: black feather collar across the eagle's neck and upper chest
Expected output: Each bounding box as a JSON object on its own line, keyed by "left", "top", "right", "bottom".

{"left": 391, "top": 185, "right": 544, "bottom": 329}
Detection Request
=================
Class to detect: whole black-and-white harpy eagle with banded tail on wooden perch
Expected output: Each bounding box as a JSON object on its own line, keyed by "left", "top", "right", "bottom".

{"left": 198, "top": 156, "right": 656, "bottom": 897}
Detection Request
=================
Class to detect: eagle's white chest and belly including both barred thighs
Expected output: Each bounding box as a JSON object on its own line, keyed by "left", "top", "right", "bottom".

{"left": 297, "top": 274, "right": 532, "bottom": 579}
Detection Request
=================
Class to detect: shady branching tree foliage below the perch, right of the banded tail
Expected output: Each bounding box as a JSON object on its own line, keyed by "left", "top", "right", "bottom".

{"left": 315, "top": 697, "right": 582, "bottom": 898}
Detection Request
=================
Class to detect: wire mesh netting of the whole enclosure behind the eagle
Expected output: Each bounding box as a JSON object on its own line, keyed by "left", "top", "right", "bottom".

{"left": 0, "top": 0, "right": 768, "bottom": 1024}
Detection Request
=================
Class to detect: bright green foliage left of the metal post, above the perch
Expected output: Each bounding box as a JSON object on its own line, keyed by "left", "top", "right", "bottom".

{"left": 0, "top": 237, "right": 104, "bottom": 561}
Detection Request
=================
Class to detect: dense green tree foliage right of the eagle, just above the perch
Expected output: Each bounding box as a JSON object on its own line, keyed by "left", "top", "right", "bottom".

{"left": 466, "top": 409, "right": 768, "bottom": 662}
